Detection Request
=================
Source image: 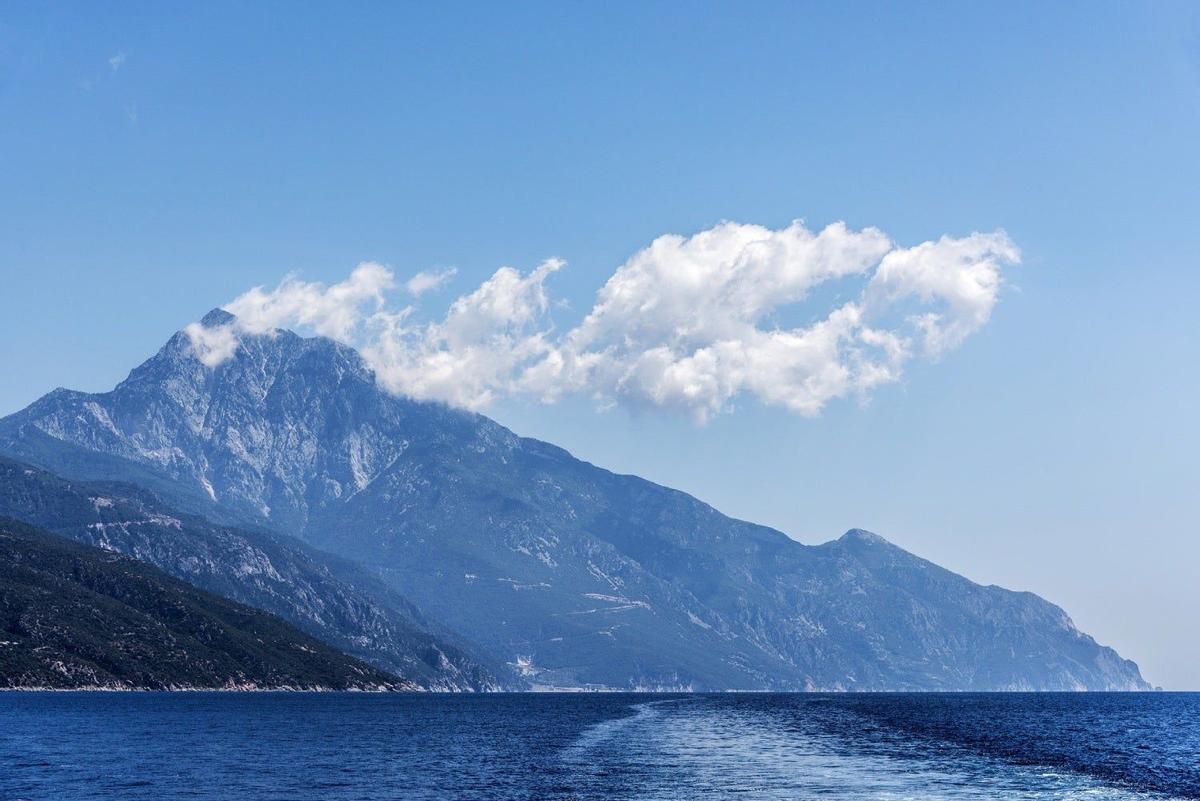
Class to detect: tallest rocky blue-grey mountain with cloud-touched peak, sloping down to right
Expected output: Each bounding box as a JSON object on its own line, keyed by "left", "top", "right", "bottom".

{"left": 0, "top": 311, "right": 1148, "bottom": 689}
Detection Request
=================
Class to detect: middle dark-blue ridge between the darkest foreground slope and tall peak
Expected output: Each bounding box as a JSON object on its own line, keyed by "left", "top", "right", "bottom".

{"left": 0, "top": 457, "right": 508, "bottom": 689}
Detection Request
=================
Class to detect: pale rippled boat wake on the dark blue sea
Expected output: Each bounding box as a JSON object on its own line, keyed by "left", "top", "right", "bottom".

{"left": 562, "top": 698, "right": 1166, "bottom": 801}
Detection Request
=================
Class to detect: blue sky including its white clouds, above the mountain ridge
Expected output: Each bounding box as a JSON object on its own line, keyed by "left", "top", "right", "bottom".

{"left": 0, "top": 2, "right": 1200, "bottom": 689}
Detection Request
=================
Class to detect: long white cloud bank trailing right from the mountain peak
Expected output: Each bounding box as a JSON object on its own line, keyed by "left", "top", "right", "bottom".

{"left": 182, "top": 222, "right": 1020, "bottom": 421}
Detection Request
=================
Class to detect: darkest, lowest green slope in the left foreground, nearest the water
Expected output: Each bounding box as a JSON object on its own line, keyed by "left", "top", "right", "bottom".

{"left": 0, "top": 518, "right": 403, "bottom": 689}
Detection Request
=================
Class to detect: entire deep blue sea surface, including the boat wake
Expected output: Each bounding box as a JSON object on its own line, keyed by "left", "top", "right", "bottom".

{"left": 0, "top": 693, "right": 1200, "bottom": 801}
